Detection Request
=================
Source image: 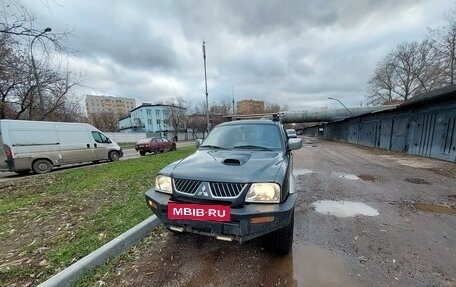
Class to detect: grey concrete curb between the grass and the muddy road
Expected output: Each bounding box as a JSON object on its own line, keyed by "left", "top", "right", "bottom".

{"left": 38, "top": 215, "right": 160, "bottom": 287}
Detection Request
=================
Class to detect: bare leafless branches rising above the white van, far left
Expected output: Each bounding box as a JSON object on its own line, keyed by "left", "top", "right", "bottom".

{"left": 0, "top": 2, "right": 83, "bottom": 121}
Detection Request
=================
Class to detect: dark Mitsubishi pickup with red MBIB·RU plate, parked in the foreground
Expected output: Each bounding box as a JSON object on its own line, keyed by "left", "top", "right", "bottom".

{"left": 145, "top": 120, "right": 302, "bottom": 254}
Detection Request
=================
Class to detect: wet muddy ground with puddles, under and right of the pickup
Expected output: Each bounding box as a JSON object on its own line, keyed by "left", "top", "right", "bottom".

{"left": 98, "top": 138, "right": 456, "bottom": 286}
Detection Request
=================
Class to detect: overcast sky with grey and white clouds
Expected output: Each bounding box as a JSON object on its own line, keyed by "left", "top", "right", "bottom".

{"left": 22, "top": 0, "right": 456, "bottom": 110}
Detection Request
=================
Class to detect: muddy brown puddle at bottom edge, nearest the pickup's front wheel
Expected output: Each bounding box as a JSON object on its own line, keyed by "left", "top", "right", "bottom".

{"left": 293, "top": 245, "right": 360, "bottom": 286}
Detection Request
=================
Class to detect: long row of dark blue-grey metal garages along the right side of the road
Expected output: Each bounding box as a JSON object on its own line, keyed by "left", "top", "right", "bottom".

{"left": 304, "top": 94, "right": 456, "bottom": 162}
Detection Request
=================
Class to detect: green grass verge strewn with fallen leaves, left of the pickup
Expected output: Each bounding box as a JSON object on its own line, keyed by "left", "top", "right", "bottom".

{"left": 0, "top": 147, "right": 194, "bottom": 286}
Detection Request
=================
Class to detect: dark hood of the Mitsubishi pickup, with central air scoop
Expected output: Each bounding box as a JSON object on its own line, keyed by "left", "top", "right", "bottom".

{"left": 172, "top": 150, "right": 283, "bottom": 183}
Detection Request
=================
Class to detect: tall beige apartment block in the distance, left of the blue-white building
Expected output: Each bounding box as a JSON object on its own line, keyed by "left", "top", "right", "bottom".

{"left": 86, "top": 95, "right": 136, "bottom": 118}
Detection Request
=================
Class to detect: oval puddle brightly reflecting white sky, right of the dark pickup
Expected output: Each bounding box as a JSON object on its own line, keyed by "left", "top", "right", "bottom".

{"left": 312, "top": 200, "right": 379, "bottom": 217}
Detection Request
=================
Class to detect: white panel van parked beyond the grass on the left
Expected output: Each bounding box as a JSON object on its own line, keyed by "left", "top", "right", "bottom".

{"left": 0, "top": 120, "right": 123, "bottom": 174}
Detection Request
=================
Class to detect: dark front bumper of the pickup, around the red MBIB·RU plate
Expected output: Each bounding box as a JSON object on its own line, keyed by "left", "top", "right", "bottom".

{"left": 145, "top": 188, "right": 297, "bottom": 242}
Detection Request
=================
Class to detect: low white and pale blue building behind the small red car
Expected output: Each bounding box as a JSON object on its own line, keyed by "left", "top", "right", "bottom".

{"left": 119, "top": 103, "right": 185, "bottom": 137}
